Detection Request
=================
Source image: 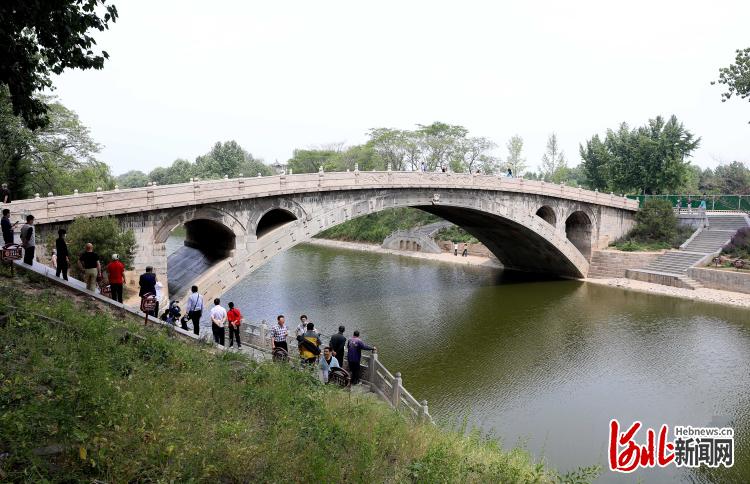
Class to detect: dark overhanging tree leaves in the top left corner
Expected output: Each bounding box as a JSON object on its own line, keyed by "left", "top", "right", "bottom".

{"left": 0, "top": 0, "right": 117, "bottom": 129}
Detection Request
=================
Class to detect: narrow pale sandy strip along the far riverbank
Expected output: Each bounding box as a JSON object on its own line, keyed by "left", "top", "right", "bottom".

{"left": 308, "top": 239, "right": 750, "bottom": 308}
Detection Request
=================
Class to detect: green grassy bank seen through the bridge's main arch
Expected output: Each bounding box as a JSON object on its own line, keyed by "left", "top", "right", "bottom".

{"left": 317, "top": 208, "right": 441, "bottom": 244}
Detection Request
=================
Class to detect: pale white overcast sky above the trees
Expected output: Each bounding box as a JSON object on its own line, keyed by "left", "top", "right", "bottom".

{"left": 55, "top": 0, "right": 750, "bottom": 174}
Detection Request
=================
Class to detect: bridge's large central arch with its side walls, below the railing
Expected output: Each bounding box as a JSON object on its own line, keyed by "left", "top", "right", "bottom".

{"left": 179, "top": 189, "right": 612, "bottom": 304}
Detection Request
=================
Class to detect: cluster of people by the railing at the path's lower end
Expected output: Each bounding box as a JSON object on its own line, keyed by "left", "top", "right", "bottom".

{"left": 271, "top": 314, "right": 377, "bottom": 385}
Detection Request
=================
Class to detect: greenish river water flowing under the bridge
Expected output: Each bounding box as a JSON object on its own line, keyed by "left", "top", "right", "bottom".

{"left": 167, "top": 239, "right": 750, "bottom": 482}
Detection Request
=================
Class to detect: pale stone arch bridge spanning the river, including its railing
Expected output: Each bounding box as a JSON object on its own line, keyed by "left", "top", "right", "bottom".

{"left": 10, "top": 170, "right": 638, "bottom": 304}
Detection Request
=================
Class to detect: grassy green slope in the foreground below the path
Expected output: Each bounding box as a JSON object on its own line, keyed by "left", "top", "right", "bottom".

{"left": 0, "top": 275, "right": 590, "bottom": 482}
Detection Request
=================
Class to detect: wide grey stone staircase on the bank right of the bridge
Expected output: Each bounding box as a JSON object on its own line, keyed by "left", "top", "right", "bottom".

{"left": 626, "top": 215, "right": 748, "bottom": 289}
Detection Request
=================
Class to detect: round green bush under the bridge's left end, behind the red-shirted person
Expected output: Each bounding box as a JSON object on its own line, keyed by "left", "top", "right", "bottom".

{"left": 65, "top": 217, "right": 136, "bottom": 273}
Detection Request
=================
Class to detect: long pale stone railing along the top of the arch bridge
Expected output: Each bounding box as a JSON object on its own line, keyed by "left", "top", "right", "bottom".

{"left": 4, "top": 170, "right": 638, "bottom": 223}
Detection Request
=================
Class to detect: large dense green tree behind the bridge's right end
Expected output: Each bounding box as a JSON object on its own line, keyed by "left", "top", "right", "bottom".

{"left": 580, "top": 115, "right": 700, "bottom": 194}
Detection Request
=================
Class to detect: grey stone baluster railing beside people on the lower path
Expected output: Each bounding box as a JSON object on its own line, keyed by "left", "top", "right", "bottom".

{"left": 242, "top": 320, "right": 432, "bottom": 422}
